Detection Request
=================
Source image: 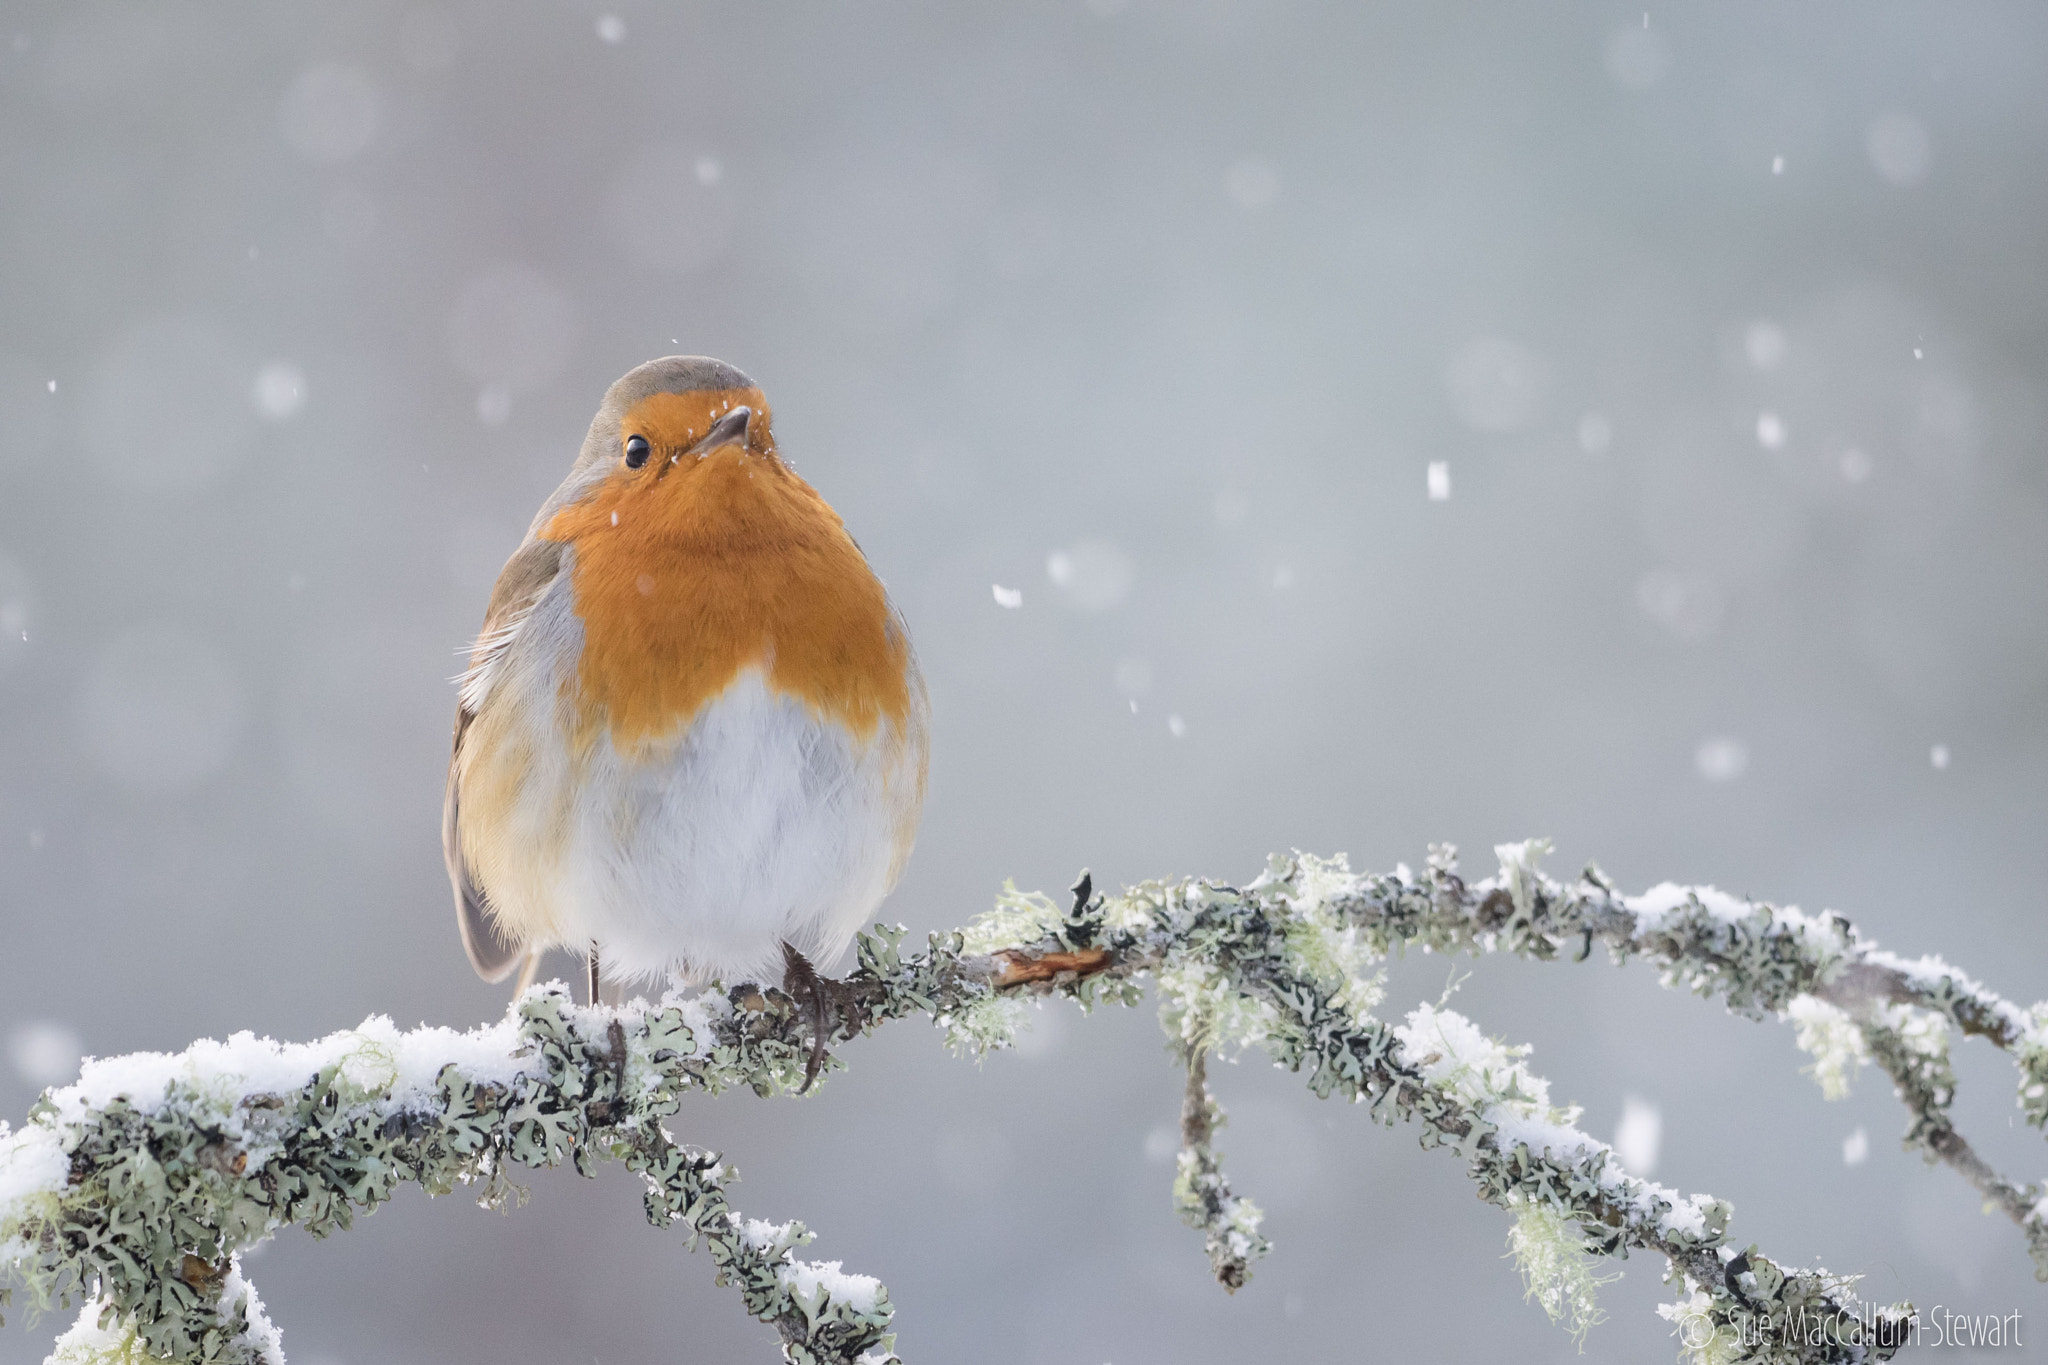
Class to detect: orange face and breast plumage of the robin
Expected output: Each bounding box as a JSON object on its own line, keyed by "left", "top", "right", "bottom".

{"left": 541, "top": 391, "right": 911, "bottom": 757}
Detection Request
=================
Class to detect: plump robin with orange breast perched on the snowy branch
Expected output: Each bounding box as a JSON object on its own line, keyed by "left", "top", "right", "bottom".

{"left": 440, "top": 356, "right": 930, "bottom": 1089}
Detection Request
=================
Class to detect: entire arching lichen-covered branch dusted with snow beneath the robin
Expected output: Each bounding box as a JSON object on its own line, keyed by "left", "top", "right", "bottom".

{"left": 0, "top": 841, "right": 2048, "bottom": 1365}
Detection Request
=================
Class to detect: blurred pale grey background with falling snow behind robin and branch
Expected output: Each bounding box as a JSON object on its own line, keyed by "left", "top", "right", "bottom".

{"left": 0, "top": 0, "right": 2048, "bottom": 1365}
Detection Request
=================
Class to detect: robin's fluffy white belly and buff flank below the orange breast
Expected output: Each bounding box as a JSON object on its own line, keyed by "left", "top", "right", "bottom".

{"left": 463, "top": 573, "right": 926, "bottom": 982}
